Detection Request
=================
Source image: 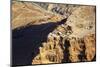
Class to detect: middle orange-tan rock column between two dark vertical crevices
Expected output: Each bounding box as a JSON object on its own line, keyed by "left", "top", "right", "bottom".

{"left": 69, "top": 38, "right": 82, "bottom": 62}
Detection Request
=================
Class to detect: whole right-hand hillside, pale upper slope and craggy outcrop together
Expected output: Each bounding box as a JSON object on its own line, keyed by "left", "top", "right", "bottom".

{"left": 32, "top": 6, "right": 96, "bottom": 64}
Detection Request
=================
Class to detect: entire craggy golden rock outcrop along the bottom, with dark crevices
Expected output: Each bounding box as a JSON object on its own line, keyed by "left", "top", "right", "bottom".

{"left": 32, "top": 34, "right": 96, "bottom": 64}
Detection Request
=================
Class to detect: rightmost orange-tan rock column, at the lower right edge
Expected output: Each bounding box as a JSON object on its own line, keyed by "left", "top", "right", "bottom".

{"left": 84, "top": 34, "right": 96, "bottom": 61}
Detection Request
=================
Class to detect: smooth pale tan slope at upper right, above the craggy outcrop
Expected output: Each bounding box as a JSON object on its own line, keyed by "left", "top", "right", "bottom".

{"left": 67, "top": 6, "right": 95, "bottom": 38}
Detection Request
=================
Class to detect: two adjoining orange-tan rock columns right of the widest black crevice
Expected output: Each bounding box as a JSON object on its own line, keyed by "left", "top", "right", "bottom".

{"left": 69, "top": 34, "right": 96, "bottom": 62}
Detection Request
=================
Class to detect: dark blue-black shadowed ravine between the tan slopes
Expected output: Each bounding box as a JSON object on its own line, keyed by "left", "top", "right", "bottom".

{"left": 12, "top": 18, "right": 67, "bottom": 65}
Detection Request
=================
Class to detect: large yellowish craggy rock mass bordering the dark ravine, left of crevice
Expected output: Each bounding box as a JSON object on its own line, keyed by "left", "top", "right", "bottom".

{"left": 32, "top": 34, "right": 64, "bottom": 64}
